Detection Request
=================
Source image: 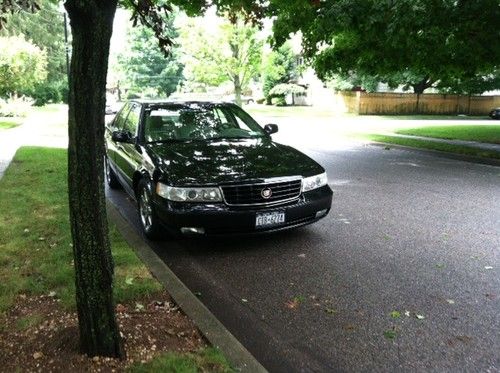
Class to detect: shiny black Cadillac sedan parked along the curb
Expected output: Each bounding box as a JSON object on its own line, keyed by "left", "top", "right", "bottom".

{"left": 105, "top": 101, "right": 332, "bottom": 238}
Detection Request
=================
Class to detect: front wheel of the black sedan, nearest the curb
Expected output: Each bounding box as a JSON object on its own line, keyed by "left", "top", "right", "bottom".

{"left": 137, "top": 179, "right": 161, "bottom": 240}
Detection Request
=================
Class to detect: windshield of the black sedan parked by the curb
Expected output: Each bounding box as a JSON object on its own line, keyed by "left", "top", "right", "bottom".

{"left": 144, "top": 104, "right": 266, "bottom": 143}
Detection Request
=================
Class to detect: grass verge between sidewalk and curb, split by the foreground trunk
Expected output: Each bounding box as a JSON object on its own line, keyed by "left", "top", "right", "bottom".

{"left": 0, "top": 147, "right": 161, "bottom": 312}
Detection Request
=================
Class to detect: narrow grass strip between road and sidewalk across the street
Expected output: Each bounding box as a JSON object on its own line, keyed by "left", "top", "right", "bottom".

{"left": 362, "top": 134, "right": 500, "bottom": 159}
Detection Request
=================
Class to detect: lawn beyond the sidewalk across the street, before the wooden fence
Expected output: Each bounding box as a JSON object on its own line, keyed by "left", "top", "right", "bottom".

{"left": 396, "top": 124, "right": 500, "bottom": 144}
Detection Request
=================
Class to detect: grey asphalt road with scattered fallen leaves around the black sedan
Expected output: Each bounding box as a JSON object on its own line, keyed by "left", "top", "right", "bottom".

{"left": 109, "top": 123, "right": 500, "bottom": 372}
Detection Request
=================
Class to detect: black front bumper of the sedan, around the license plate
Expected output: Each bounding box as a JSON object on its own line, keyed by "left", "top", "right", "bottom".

{"left": 155, "top": 186, "right": 333, "bottom": 236}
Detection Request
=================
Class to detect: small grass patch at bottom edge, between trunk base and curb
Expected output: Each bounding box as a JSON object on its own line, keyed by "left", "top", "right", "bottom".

{"left": 128, "top": 348, "right": 234, "bottom": 373}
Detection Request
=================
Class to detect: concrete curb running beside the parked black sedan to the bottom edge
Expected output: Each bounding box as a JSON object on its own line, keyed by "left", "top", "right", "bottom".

{"left": 106, "top": 200, "right": 267, "bottom": 373}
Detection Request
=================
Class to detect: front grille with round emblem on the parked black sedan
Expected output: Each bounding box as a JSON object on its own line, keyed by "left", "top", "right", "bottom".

{"left": 221, "top": 179, "right": 302, "bottom": 206}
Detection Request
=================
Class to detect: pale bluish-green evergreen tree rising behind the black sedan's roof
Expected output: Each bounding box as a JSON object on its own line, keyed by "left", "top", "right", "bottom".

{"left": 119, "top": 17, "right": 184, "bottom": 96}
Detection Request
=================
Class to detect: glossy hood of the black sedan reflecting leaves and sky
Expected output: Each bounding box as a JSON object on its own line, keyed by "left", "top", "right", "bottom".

{"left": 147, "top": 138, "right": 324, "bottom": 186}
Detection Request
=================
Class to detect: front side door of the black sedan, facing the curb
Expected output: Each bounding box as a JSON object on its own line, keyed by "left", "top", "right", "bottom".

{"left": 115, "top": 103, "right": 142, "bottom": 192}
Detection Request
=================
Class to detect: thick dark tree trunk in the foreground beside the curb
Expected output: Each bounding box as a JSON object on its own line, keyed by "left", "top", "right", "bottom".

{"left": 65, "top": 0, "right": 123, "bottom": 357}
